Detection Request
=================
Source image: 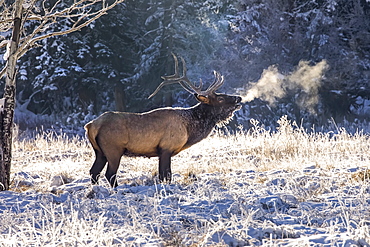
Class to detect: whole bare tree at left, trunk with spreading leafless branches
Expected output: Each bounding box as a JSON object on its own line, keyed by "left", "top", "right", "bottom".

{"left": 0, "top": 0, "right": 124, "bottom": 191}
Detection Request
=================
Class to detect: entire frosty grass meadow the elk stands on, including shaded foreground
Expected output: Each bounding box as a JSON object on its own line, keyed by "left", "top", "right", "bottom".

{"left": 0, "top": 118, "right": 370, "bottom": 246}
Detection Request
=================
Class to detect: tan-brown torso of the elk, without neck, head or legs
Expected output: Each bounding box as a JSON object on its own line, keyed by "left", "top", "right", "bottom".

{"left": 85, "top": 108, "right": 187, "bottom": 157}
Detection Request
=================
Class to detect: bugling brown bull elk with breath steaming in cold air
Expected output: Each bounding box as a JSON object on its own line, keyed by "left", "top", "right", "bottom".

{"left": 85, "top": 54, "right": 241, "bottom": 187}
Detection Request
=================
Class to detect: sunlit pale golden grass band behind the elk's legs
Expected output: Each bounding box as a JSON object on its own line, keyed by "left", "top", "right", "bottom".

{"left": 8, "top": 117, "right": 370, "bottom": 189}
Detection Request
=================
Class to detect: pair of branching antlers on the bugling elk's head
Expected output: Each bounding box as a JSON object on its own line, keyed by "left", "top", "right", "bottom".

{"left": 148, "top": 53, "right": 224, "bottom": 99}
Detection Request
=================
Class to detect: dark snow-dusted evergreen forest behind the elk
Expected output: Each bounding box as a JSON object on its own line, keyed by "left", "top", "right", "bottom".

{"left": 0, "top": 0, "right": 370, "bottom": 132}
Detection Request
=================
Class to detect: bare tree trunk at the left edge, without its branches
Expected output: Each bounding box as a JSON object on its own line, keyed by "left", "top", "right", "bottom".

{"left": 0, "top": 0, "right": 23, "bottom": 191}
